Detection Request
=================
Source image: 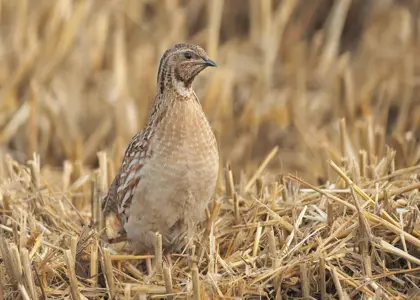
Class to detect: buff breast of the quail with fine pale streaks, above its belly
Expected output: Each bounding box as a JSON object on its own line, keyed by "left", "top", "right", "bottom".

{"left": 144, "top": 101, "right": 219, "bottom": 184}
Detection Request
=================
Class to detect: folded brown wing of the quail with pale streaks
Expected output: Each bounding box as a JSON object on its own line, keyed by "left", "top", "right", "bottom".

{"left": 102, "top": 131, "right": 150, "bottom": 223}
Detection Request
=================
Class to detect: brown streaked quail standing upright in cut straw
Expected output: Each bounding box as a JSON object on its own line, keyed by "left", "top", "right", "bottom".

{"left": 102, "top": 43, "right": 219, "bottom": 253}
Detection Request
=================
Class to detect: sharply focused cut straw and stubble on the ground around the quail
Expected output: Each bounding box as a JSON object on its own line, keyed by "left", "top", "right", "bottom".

{"left": 0, "top": 134, "right": 420, "bottom": 299}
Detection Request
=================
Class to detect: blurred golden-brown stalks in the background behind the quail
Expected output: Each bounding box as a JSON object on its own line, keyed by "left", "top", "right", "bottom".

{"left": 0, "top": 0, "right": 420, "bottom": 183}
